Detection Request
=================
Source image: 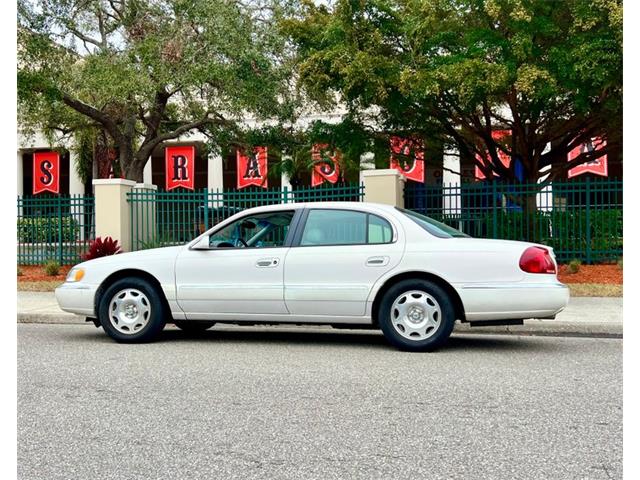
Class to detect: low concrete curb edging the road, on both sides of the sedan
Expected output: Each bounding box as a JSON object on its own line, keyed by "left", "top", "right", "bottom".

{"left": 17, "top": 313, "right": 623, "bottom": 338}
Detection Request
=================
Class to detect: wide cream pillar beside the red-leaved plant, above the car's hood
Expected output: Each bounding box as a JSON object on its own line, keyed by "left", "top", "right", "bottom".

{"left": 93, "top": 178, "right": 136, "bottom": 252}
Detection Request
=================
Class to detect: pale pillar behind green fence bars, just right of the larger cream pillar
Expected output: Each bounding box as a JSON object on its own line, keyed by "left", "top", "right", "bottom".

{"left": 130, "top": 183, "right": 158, "bottom": 250}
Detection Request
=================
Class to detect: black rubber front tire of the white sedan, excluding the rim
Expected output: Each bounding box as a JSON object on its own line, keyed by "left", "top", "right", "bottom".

{"left": 98, "top": 277, "right": 169, "bottom": 343}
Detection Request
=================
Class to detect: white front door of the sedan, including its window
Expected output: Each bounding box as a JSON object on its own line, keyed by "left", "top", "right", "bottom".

{"left": 175, "top": 210, "right": 295, "bottom": 320}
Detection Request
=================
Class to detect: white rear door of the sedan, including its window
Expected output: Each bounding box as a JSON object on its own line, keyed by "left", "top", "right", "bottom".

{"left": 284, "top": 208, "right": 404, "bottom": 316}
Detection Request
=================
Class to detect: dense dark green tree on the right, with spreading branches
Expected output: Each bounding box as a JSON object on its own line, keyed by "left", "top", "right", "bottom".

{"left": 281, "top": 0, "right": 622, "bottom": 181}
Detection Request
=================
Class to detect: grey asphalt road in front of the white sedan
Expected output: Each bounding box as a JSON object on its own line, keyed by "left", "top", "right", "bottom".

{"left": 18, "top": 324, "right": 622, "bottom": 480}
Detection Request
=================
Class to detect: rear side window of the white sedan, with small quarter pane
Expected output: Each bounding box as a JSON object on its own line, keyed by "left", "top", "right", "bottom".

{"left": 300, "top": 209, "right": 393, "bottom": 246}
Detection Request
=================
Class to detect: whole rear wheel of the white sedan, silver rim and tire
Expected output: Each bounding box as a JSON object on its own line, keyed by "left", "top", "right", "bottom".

{"left": 378, "top": 279, "right": 455, "bottom": 352}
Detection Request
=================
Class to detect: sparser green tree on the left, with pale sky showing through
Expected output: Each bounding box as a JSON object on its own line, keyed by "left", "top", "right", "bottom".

{"left": 18, "top": 0, "right": 291, "bottom": 181}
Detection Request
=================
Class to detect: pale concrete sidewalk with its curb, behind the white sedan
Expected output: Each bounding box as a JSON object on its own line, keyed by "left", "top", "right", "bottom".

{"left": 18, "top": 292, "right": 622, "bottom": 337}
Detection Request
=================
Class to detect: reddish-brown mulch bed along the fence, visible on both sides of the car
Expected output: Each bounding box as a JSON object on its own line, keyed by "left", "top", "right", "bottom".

{"left": 18, "top": 265, "right": 622, "bottom": 285}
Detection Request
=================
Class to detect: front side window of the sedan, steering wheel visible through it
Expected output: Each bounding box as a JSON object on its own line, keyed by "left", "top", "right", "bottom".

{"left": 209, "top": 211, "right": 294, "bottom": 248}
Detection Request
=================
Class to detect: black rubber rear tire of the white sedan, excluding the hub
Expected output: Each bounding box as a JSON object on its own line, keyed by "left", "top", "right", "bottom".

{"left": 377, "top": 279, "right": 455, "bottom": 352}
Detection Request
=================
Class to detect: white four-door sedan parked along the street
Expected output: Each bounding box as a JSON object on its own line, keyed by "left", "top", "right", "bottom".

{"left": 56, "top": 202, "right": 569, "bottom": 351}
